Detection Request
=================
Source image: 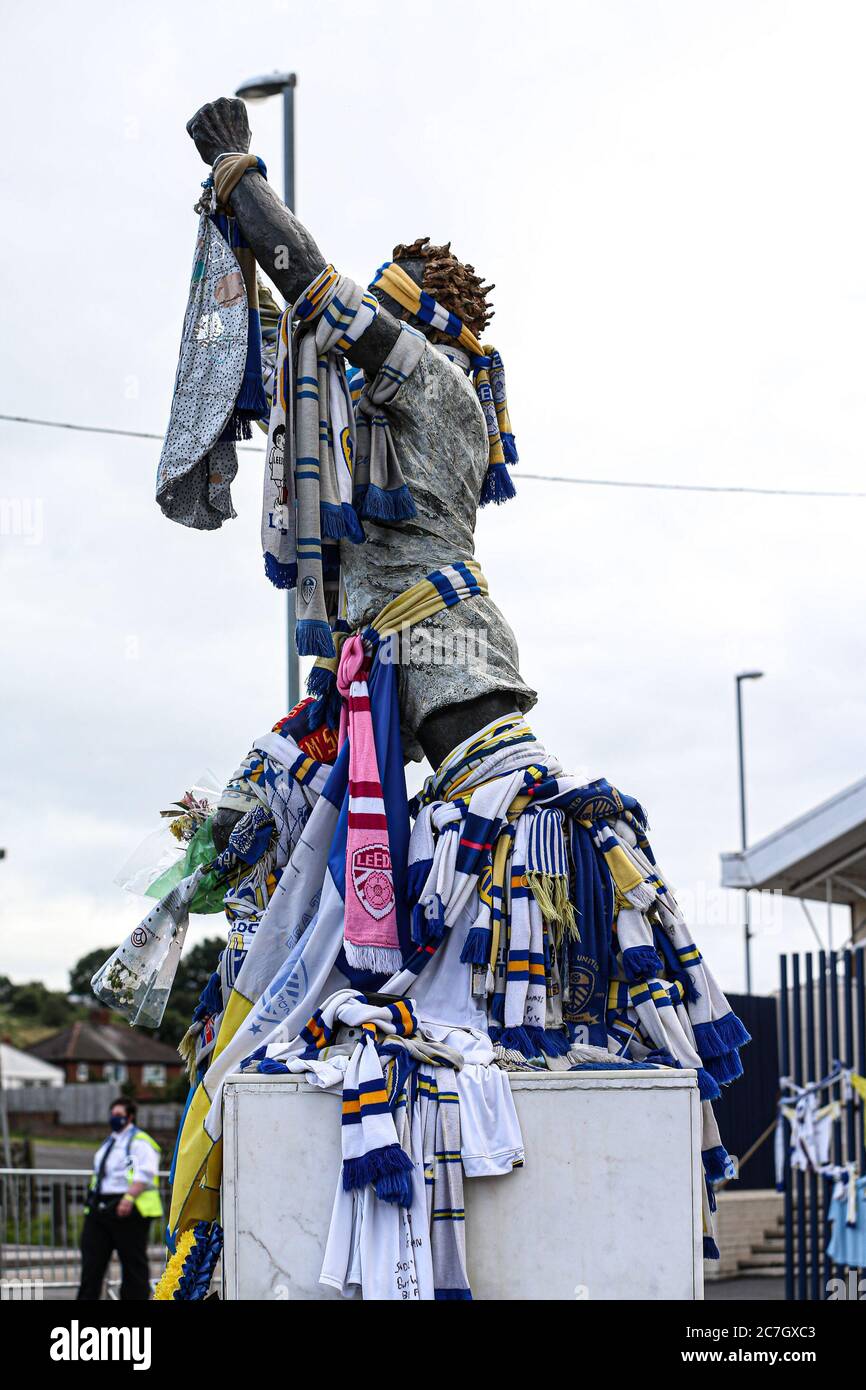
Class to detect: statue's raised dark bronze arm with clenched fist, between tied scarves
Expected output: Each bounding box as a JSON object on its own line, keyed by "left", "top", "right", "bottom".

{"left": 186, "top": 96, "right": 400, "bottom": 375}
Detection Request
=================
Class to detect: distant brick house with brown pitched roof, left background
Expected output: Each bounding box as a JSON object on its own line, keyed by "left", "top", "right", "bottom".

{"left": 28, "top": 1019, "right": 183, "bottom": 1097}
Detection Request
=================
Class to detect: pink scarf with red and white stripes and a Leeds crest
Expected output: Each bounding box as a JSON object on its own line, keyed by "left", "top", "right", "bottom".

{"left": 336, "top": 635, "right": 403, "bottom": 974}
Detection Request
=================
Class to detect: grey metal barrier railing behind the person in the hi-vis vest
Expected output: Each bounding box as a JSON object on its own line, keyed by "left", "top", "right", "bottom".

{"left": 0, "top": 1168, "right": 170, "bottom": 1298}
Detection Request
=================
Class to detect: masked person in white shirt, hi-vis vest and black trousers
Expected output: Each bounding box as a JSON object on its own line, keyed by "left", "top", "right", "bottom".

{"left": 78, "top": 1098, "right": 163, "bottom": 1302}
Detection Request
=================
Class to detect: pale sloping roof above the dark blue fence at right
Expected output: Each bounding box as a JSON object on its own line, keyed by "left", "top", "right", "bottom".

{"left": 721, "top": 777, "right": 866, "bottom": 904}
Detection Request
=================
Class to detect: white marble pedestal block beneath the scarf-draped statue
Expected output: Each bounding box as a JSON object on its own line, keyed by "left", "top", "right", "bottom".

{"left": 222, "top": 1070, "right": 703, "bottom": 1300}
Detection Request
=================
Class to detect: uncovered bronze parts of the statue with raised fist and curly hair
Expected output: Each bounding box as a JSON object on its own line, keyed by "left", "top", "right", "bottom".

{"left": 188, "top": 97, "right": 535, "bottom": 795}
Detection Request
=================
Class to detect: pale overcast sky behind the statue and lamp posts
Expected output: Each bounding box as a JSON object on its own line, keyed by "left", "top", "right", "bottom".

{"left": 0, "top": 0, "right": 866, "bottom": 991}
